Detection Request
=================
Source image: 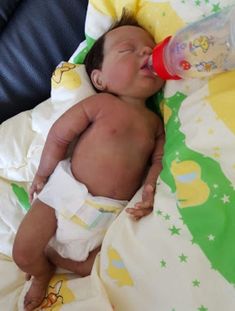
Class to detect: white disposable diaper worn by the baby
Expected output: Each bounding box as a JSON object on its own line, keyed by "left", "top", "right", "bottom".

{"left": 38, "top": 159, "right": 128, "bottom": 261}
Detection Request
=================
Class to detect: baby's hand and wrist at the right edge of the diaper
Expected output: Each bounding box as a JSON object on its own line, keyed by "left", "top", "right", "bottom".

{"left": 126, "top": 184, "right": 154, "bottom": 220}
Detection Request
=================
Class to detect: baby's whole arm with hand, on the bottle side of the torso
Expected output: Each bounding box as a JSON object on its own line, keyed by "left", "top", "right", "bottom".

{"left": 126, "top": 121, "right": 165, "bottom": 220}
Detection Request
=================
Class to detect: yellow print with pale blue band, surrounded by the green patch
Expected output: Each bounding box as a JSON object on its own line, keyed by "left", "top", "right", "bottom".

{"left": 171, "top": 161, "right": 210, "bottom": 208}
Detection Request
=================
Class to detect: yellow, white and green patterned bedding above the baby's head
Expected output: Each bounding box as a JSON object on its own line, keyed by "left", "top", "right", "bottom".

{"left": 70, "top": 0, "right": 235, "bottom": 64}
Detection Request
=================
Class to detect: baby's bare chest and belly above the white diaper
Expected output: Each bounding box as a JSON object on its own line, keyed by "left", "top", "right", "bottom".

{"left": 72, "top": 94, "right": 161, "bottom": 200}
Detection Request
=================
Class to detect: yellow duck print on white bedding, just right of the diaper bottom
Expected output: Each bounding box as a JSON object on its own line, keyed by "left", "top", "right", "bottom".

{"left": 107, "top": 246, "right": 134, "bottom": 286}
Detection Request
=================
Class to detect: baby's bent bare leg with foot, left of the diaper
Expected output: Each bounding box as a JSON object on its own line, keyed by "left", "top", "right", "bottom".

{"left": 12, "top": 200, "right": 57, "bottom": 311}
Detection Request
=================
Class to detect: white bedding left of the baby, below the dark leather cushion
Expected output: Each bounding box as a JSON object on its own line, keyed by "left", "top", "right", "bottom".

{"left": 0, "top": 62, "right": 95, "bottom": 256}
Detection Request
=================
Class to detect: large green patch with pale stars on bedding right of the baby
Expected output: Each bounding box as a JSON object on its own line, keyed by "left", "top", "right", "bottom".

{"left": 161, "top": 92, "right": 235, "bottom": 283}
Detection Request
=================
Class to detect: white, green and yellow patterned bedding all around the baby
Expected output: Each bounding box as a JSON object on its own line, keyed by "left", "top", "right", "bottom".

{"left": 0, "top": 0, "right": 235, "bottom": 311}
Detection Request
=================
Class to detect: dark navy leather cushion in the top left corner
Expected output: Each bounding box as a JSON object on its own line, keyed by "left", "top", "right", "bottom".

{"left": 0, "top": 0, "right": 87, "bottom": 123}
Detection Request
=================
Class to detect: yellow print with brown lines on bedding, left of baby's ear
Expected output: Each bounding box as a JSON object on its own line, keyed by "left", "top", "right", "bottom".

{"left": 51, "top": 62, "right": 81, "bottom": 90}
